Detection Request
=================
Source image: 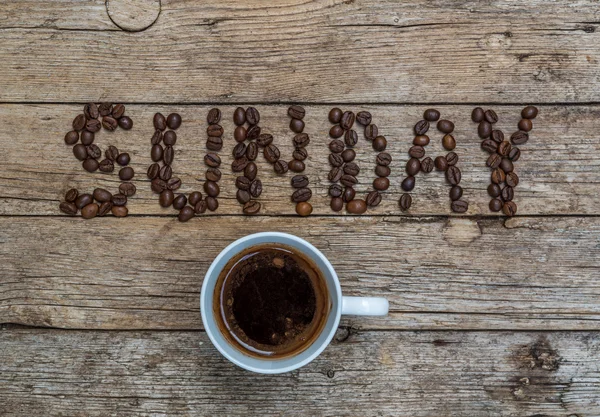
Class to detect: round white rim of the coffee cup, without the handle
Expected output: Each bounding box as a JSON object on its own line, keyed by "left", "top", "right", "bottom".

{"left": 200, "top": 232, "right": 342, "bottom": 374}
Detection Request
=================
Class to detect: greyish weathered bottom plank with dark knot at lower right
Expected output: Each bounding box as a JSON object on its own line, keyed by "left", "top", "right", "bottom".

{"left": 0, "top": 329, "right": 600, "bottom": 417}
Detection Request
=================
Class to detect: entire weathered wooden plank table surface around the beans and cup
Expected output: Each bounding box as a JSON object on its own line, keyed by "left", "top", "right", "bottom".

{"left": 0, "top": 0, "right": 600, "bottom": 417}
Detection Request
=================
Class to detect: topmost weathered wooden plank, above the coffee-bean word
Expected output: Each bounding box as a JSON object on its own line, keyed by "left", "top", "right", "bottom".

{"left": 0, "top": 0, "right": 600, "bottom": 103}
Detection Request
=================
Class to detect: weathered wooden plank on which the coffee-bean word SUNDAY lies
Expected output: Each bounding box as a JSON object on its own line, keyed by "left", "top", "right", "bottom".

{"left": 0, "top": 104, "right": 600, "bottom": 216}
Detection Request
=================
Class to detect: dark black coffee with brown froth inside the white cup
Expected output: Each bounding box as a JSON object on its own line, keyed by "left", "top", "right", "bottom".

{"left": 213, "top": 244, "right": 331, "bottom": 359}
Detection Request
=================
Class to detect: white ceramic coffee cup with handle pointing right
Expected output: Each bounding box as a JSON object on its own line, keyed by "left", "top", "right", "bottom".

{"left": 200, "top": 232, "right": 388, "bottom": 374}
